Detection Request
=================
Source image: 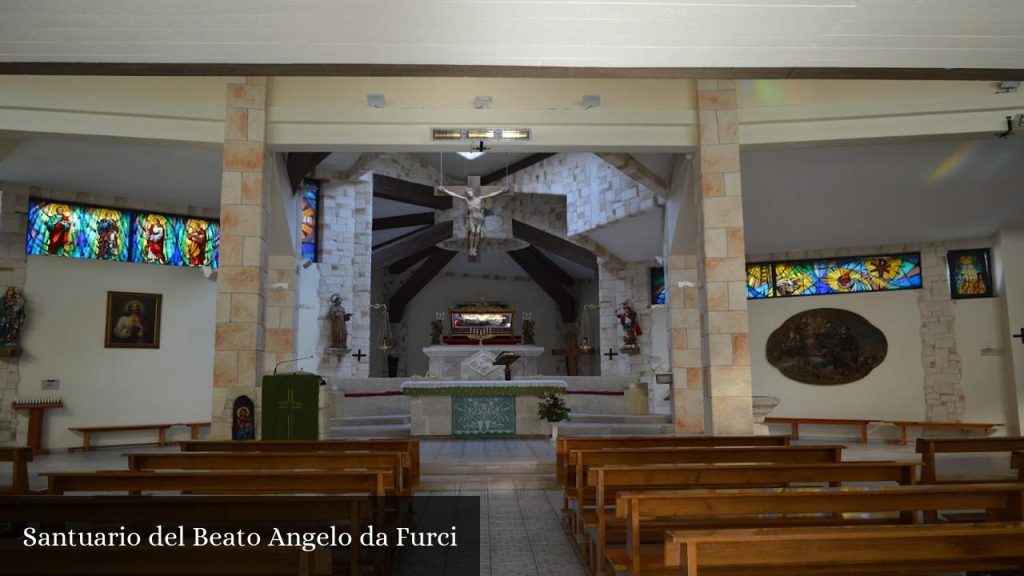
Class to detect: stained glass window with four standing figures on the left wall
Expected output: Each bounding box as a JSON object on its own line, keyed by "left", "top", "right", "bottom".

{"left": 26, "top": 200, "right": 220, "bottom": 268}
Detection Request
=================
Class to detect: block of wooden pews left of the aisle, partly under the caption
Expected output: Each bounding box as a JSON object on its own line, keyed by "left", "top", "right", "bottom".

{"left": 0, "top": 440, "right": 419, "bottom": 575}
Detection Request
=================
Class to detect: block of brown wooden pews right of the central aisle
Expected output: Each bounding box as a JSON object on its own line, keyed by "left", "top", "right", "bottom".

{"left": 556, "top": 437, "right": 1024, "bottom": 576}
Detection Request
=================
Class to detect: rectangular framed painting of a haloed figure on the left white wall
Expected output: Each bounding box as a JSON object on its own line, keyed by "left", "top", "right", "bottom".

{"left": 103, "top": 292, "right": 163, "bottom": 348}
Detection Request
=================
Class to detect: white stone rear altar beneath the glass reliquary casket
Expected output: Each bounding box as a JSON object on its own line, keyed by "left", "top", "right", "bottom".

{"left": 423, "top": 344, "right": 544, "bottom": 380}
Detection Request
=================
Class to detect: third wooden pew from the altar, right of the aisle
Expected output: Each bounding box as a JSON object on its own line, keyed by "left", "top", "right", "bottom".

{"left": 582, "top": 462, "right": 920, "bottom": 561}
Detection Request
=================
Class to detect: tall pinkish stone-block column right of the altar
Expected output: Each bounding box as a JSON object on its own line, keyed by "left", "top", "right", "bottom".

{"left": 696, "top": 80, "right": 754, "bottom": 436}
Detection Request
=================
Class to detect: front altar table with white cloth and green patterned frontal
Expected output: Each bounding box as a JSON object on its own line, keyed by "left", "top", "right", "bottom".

{"left": 401, "top": 377, "right": 565, "bottom": 437}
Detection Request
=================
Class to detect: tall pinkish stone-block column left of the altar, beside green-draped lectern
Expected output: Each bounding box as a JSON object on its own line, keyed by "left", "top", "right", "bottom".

{"left": 210, "top": 77, "right": 269, "bottom": 440}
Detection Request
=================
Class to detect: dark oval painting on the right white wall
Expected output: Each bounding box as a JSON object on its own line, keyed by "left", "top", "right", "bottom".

{"left": 767, "top": 308, "right": 889, "bottom": 385}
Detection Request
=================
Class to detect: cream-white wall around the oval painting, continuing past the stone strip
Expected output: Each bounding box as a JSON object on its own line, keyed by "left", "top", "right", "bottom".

{"left": 749, "top": 290, "right": 1013, "bottom": 437}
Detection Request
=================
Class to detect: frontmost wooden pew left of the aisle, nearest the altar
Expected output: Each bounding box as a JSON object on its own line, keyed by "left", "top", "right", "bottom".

{"left": 180, "top": 439, "right": 420, "bottom": 490}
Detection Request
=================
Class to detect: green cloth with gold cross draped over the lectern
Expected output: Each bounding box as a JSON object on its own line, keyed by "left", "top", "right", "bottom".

{"left": 261, "top": 373, "right": 323, "bottom": 440}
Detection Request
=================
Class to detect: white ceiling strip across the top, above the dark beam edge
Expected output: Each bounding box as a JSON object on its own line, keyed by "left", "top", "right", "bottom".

{"left": 0, "top": 0, "right": 1024, "bottom": 70}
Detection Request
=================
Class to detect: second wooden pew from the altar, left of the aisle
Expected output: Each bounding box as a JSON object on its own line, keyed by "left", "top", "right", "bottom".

{"left": 125, "top": 452, "right": 409, "bottom": 495}
